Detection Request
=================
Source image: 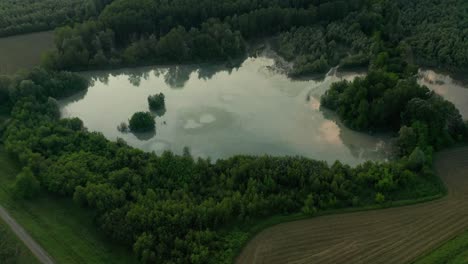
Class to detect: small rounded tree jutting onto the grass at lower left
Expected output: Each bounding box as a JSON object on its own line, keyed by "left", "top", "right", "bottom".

{"left": 13, "top": 167, "right": 40, "bottom": 199}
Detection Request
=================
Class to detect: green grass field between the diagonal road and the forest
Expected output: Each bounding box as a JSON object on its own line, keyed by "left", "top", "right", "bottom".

{"left": 0, "top": 146, "right": 136, "bottom": 264}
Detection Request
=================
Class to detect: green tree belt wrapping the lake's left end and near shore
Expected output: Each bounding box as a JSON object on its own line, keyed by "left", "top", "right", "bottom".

{"left": 3, "top": 69, "right": 442, "bottom": 263}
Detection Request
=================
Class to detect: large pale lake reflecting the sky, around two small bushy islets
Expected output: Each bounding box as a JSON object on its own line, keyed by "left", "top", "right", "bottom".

{"left": 61, "top": 57, "right": 389, "bottom": 164}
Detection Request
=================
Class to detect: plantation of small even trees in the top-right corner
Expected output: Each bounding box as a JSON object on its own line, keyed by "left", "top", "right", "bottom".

{"left": 398, "top": 0, "right": 468, "bottom": 71}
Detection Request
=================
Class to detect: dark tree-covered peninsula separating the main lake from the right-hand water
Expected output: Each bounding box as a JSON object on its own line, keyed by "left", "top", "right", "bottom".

{"left": 322, "top": 71, "right": 467, "bottom": 160}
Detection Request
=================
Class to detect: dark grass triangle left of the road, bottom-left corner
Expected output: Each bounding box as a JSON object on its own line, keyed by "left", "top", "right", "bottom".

{"left": 0, "top": 220, "right": 40, "bottom": 264}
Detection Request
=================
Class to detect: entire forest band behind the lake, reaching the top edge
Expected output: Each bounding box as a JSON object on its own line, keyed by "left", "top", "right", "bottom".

{"left": 44, "top": 0, "right": 468, "bottom": 76}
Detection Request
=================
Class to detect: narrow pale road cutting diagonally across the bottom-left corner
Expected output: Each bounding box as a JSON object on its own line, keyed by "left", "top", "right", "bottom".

{"left": 0, "top": 206, "right": 54, "bottom": 264}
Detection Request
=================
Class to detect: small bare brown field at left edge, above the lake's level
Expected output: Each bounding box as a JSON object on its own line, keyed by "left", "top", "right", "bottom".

{"left": 0, "top": 31, "right": 54, "bottom": 74}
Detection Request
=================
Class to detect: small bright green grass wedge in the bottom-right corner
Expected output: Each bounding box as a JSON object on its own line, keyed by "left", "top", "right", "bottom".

{"left": 414, "top": 231, "right": 468, "bottom": 264}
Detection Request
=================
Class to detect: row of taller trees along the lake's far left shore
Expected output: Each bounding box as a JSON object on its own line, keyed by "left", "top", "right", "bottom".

{"left": 43, "top": 20, "right": 245, "bottom": 69}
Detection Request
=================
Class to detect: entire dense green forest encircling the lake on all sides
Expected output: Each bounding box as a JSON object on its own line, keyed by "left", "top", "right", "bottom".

{"left": 0, "top": 0, "right": 468, "bottom": 263}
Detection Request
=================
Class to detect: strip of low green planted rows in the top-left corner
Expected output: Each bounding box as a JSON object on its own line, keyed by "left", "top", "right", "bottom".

{"left": 0, "top": 0, "right": 112, "bottom": 37}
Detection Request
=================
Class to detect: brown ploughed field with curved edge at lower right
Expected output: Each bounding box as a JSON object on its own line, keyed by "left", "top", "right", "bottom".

{"left": 236, "top": 148, "right": 468, "bottom": 264}
